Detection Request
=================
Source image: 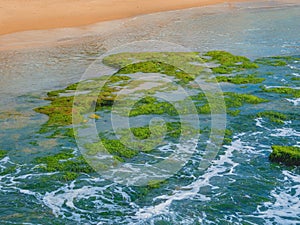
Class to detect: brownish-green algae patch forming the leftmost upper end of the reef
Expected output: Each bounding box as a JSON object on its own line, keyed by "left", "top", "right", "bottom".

{"left": 34, "top": 75, "right": 130, "bottom": 126}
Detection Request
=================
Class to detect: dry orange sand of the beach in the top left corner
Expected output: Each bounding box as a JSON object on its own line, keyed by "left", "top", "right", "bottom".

{"left": 0, "top": 0, "right": 254, "bottom": 35}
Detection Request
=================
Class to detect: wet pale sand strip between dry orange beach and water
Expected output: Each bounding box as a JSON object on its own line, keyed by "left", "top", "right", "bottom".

{"left": 0, "top": 0, "right": 298, "bottom": 51}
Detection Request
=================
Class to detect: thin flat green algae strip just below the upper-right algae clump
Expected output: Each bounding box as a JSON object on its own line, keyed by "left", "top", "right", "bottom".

{"left": 216, "top": 74, "right": 265, "bottom": 84}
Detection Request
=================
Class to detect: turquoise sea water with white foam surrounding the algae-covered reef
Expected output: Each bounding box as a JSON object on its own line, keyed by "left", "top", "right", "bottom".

{"left": 0, "top": 2, "right": 300, "bottom": 224}
